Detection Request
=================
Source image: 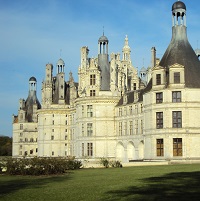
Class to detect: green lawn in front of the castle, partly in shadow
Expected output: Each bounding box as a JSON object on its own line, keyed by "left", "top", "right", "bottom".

{"left": 0, "top": 164, "right": 200, "bottom": 201}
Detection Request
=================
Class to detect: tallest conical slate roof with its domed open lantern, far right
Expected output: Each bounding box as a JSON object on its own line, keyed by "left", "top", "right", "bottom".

{"left": 159, "top": 1, "right": 200, "bottom": 88}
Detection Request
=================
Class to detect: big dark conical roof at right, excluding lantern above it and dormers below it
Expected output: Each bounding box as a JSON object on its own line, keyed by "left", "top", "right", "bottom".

{"left": 159, "top": 26, "right": 200, "bottom": 88}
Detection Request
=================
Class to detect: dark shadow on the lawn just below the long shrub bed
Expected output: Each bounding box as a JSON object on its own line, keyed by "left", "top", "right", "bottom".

{"left": 0, "top": 172, "right": 73, "bottom": 197}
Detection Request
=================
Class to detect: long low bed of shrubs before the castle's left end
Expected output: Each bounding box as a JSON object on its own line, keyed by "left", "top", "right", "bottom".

{"left": 5, "top": 157, "right": 82, "bottom": 175}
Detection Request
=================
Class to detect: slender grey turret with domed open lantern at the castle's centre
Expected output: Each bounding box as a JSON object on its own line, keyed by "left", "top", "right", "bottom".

{"left": 98, "top": 33, "right": 110, "bottom": 91}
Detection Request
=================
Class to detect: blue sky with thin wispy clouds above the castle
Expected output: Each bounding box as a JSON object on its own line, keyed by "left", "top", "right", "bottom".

{"left": 0, "top": 0, "right": 200, "bottom": 136}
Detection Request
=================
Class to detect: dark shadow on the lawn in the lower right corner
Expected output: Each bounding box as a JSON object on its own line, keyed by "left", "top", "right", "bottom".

{"left": 105, "top": 172, "right": 200, "bottom": 201}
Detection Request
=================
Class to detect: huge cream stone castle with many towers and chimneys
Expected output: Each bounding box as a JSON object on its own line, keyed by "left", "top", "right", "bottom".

{"left": 13, "top": 1, "right": 200, "bottom": 162}
